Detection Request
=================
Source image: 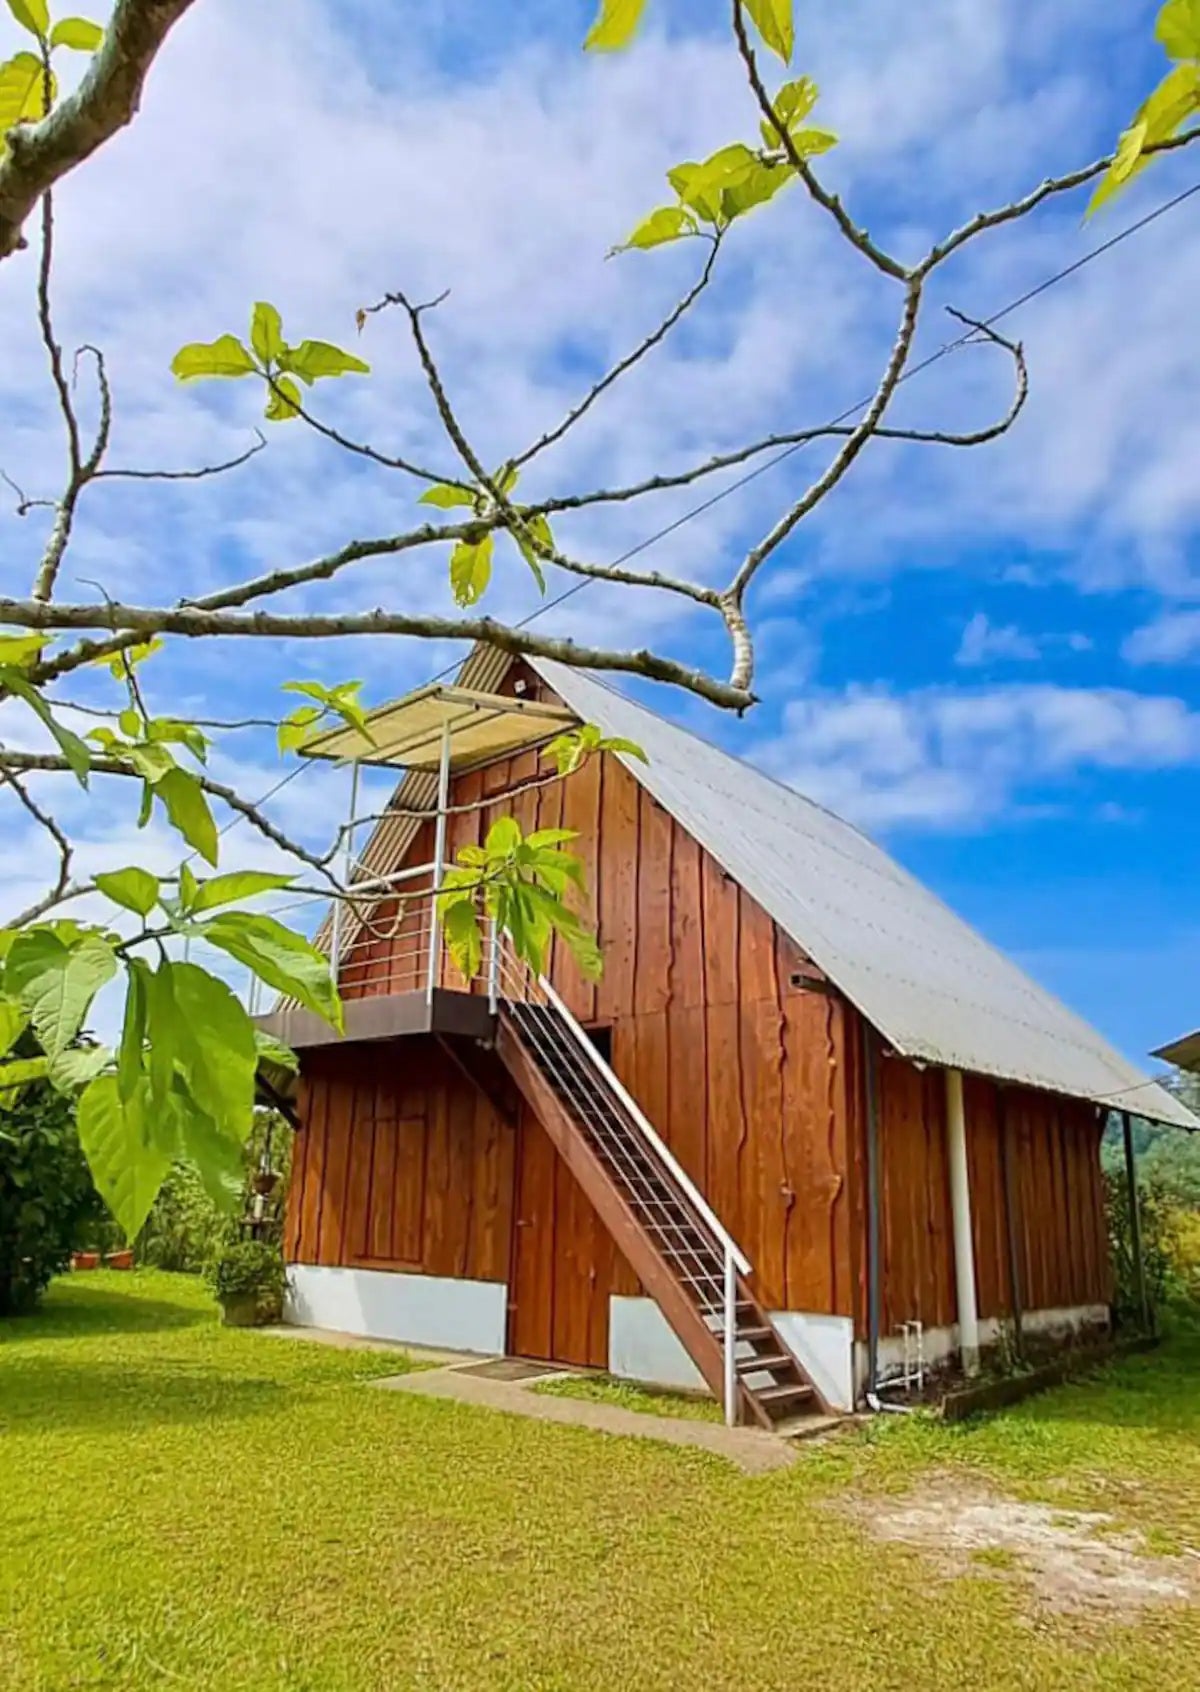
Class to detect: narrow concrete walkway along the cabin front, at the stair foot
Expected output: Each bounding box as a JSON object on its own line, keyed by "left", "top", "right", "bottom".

{"left": 371, "top": 1364, "right": 838, "bottom": 1475}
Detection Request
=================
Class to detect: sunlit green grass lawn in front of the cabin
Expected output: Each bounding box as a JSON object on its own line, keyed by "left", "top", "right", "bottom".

{"left": 0, "top": 1272, "right": 1200, "bottom": 1692}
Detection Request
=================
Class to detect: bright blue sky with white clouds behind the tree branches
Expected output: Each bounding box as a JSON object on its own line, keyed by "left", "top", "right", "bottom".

{"left": 0, "top": 0, "right": 1200, "bottom": 1056}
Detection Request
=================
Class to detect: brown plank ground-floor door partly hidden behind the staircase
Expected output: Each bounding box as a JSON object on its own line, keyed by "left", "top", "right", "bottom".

{"left": 508, "top": 1108, "right": 614, "bottom": 1369}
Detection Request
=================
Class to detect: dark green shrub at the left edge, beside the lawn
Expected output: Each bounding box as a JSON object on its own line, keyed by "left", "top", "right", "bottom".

{"left": 0, "top": 1081, "right": 103, "bottom": 1316}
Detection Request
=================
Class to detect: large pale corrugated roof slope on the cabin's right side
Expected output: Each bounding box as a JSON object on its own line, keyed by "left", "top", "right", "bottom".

{"left": 528, "top": 653, "right": 1200, "bottom": 1129}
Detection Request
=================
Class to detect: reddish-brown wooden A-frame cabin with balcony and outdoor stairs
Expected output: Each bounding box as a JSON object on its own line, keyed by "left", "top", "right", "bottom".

{"left": 269, "top": 648, "right": 1193, "bottom": 1423}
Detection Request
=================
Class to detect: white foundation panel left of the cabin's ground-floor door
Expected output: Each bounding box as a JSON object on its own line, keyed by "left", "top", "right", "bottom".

{"left": 284, "top": 1264, "right": 508, "bottom": 1357}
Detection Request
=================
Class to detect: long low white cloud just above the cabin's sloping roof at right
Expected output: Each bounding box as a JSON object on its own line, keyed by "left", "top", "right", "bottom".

{"left": 758, "top": 685, "right": 1200, "bottom": 829}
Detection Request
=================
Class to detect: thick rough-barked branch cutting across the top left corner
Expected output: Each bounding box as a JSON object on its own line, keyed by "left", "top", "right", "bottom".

{"left": 0, "top": 0, "right": 193, "bottom": 261}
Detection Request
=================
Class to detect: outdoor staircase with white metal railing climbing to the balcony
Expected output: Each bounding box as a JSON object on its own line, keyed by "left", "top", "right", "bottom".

{"left": 493, "top": 941, "right": 826, "bottom": 1428}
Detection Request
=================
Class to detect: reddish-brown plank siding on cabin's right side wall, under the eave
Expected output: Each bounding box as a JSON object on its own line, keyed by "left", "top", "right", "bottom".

{"left": 880, "top": 1058, "right": 1112, "bottom": 1333}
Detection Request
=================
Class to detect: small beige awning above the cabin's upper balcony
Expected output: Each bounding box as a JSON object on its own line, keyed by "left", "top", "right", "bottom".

{"left": 300, "top": 682, "right": 579, "bottom": 770}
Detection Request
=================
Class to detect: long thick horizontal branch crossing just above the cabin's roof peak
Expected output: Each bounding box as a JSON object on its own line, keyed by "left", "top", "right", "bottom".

{"left": 0, "top": 599, "right": 755, "bottom": 711}
